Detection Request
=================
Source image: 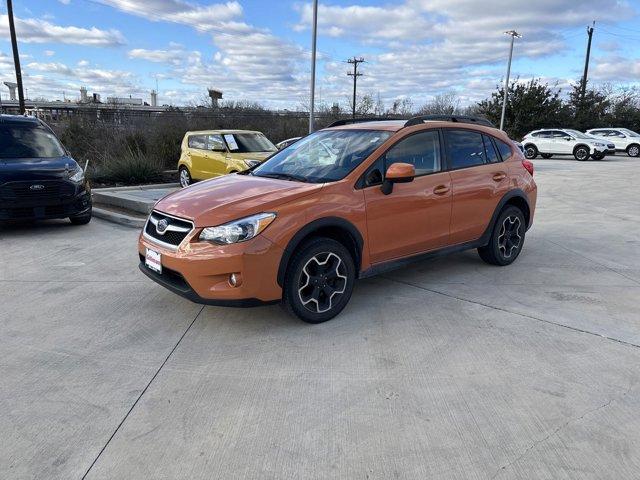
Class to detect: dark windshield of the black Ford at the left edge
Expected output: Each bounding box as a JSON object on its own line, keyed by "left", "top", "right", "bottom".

{"left": 0, "top": 125, "right": 65, "bottom": 158}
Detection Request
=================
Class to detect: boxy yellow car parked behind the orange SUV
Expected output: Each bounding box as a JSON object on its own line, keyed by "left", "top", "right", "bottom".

{"left": 178, "top": 130, "right": 278, "bottom": 187}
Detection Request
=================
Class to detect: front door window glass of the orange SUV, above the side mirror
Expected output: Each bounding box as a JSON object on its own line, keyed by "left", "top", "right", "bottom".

{"left": 385, "top": 130, "right": 440, "bottom": 175}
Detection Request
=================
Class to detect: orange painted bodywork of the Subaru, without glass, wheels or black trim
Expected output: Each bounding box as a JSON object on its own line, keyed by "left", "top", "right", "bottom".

{"left": 139, "top": 122, "right": 537, "bottom": 301}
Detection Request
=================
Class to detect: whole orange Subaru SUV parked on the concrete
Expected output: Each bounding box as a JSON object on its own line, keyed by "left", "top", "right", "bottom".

{"left": 138, "top": 116, "right": 537, "bottom": 323}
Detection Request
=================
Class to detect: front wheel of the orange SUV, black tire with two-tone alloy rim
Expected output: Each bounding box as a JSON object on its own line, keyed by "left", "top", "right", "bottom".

{"left": 282, "top": 237, "right": 356, "bottom": 323}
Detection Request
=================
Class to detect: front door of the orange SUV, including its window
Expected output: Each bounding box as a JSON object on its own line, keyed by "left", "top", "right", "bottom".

{"left": 364, "top": 130, "right": 451, "bottom": 263}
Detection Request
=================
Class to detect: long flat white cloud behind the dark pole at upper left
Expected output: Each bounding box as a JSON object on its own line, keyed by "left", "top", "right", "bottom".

{"left": 0, "top": 15, "right": 125, "bottom": 47}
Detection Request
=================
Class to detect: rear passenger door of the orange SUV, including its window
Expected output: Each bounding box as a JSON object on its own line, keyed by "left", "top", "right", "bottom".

{"left": 443, "top": 128, "right": 509, "bottom": 245}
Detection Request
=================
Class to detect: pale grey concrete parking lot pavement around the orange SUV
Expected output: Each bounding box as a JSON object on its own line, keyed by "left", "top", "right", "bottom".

{"left": 0, "top": 156, "right": 640, "bottom": 480}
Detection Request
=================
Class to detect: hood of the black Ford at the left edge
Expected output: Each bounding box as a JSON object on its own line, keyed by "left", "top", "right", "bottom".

{"left": 0, "top": 157, "right": 78, "bottom": 182}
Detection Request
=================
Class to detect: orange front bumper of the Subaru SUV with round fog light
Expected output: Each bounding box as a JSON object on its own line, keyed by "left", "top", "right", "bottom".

{"left": 138, "top": 233, "right": 282, "bottom": 307}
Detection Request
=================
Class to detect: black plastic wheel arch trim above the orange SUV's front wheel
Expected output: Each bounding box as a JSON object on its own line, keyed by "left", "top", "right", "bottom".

{"left": 277, "top": 217, "right": 364, "bottom": 287}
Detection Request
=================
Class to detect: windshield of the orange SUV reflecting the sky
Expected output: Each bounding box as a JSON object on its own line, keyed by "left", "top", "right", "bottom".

{"left": 251, "top": 130, "right": 393, "bottom": 183}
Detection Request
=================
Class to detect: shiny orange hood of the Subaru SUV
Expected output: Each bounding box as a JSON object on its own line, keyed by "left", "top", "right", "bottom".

{"left": 154, "top": 175, "right": 322, "bottom": 227}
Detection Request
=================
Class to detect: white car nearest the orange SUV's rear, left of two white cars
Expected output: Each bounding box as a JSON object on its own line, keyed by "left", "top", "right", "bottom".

{"left": 522, "top": 128, "right": 616, "bottom": 161}
